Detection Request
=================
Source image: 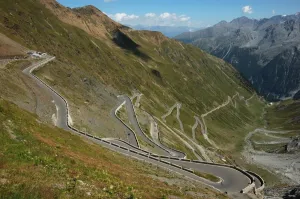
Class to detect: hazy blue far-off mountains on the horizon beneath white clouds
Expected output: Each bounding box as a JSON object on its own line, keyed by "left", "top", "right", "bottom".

{"left": 130, "top": 25, "right": 201, "bottom": 37}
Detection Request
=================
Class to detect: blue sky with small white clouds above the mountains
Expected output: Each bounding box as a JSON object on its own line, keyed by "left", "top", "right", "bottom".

{"left": 57, "top": 0, "right": 300, "bottom": 28}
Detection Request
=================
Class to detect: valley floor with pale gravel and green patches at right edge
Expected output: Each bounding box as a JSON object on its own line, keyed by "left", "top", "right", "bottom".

{"left": 244, "top": 100, "right": 300, "bottom": 190}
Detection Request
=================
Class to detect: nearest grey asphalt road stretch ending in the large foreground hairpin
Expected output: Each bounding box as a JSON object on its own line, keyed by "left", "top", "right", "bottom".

{"left": 23, "top": 57, "right": 262, "bottom": 193}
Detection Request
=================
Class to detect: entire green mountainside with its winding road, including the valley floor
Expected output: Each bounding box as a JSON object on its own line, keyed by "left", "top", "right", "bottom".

{"left": 0, "top": 0, "right": 300, "bottom": 198}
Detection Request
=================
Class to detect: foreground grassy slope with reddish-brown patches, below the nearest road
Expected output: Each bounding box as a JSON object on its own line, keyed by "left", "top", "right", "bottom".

{"left": 0, "top": 99, "right": 229, "bottom": 198}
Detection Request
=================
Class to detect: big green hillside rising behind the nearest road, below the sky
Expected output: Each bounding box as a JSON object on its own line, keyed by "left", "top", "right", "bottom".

{"left": 0, "top": 0, "right": 264, "bottom": 173}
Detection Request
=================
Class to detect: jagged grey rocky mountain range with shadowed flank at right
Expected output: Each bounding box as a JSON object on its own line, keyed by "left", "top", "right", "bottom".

{"left": 175, "top": 13, "right": 300, "bottom": 101}
